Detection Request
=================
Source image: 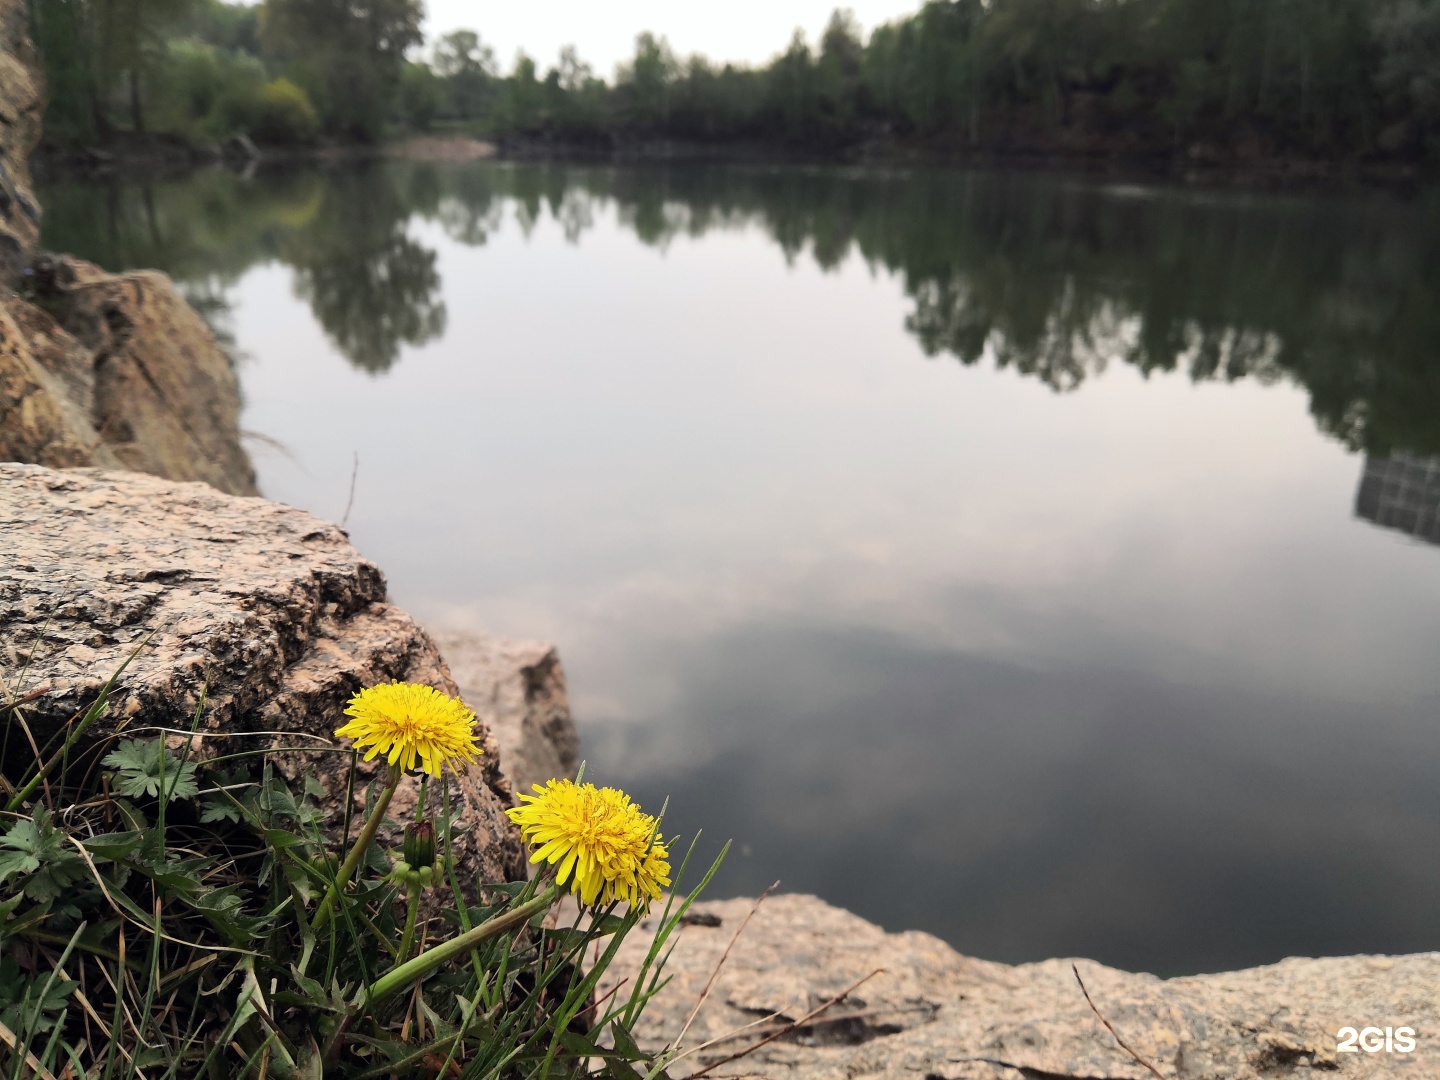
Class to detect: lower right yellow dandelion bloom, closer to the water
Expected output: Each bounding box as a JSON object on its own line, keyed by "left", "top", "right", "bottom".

{"left": 505, "top": 780, "right": 670, "bottom": 909}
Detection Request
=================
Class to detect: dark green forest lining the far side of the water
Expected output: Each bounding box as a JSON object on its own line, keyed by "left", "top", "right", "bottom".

{"left": 32, "top": 0, "right": 1440, "bottom": 166}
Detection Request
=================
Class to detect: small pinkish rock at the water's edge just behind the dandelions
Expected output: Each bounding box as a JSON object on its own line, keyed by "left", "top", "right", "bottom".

{"left": 428, "top": 626, "right": 580, "bottom": 792}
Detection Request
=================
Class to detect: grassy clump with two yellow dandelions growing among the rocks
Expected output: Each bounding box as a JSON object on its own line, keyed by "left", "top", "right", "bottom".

{"left": 0, "top": 680, "right": 724, "bottom": 1080}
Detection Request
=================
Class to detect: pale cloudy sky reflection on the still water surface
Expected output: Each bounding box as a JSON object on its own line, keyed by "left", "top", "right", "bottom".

{"left": 233, "top": 190, "right": 1440, "bottom": 971}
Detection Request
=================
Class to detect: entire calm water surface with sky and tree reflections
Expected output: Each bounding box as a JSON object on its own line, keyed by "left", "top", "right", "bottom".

{"left": 42, "top": 163, "right": 1440, "bottom": 973}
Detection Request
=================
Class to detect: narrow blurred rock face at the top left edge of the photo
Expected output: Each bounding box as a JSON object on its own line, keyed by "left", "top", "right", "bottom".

{"left": 0, "top": 0, "right": 45, "bottom": 281}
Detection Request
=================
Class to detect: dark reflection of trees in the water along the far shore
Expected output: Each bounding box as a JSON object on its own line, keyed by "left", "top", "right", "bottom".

{"left": 42, "top": 161, "right": 1440, "bottom": 452}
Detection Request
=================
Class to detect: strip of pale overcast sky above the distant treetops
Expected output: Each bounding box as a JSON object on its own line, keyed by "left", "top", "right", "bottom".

{"left": 425, "top": 0, "right": 920, "bottom": 78}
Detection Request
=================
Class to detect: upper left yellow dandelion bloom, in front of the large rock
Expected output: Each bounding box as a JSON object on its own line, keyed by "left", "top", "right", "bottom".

{"left": 336, "top": 683, "right": 481, "bottom": 776}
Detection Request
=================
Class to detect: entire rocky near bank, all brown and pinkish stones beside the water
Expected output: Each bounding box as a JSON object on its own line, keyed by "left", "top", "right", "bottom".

{"left": 0, "top": 0, "right": 1440, "bottom": 1080}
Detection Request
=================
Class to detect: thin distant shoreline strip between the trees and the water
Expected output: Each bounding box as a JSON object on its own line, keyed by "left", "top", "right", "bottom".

{"left": 32, "top": 134, "right": 1440, "bottom": 197}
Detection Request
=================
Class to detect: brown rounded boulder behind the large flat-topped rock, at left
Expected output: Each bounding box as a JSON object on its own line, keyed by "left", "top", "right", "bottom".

{"left": 11, "top": 255, "right": 255, "bottom": 495}
